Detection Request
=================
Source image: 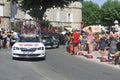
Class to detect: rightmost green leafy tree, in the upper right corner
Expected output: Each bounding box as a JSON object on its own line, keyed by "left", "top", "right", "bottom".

{"left": 101, "top": 0, "right": 120, "bottom": 26}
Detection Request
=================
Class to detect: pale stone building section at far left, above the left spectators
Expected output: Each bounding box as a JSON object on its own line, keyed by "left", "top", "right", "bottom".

{"left": 0, "top": 0, "right": 25, "bottom": 29}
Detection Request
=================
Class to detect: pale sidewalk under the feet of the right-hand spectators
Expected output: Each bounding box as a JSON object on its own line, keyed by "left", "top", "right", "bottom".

{"left": 75, "top": 51, "right": 120, "bottom": 69}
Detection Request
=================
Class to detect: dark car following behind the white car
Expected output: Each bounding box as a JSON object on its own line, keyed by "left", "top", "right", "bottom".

{"left": 41, "top": 34, "right": 59, "bottom": 48}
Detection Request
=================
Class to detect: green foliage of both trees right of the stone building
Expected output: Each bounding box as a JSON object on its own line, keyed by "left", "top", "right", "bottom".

{"left": 82, "top": 0, "right": 120, "bottom": 26}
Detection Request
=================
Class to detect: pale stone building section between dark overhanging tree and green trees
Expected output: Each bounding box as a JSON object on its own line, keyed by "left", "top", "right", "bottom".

{"left": 45, "top": 2, "right": 82, "bottom": 29}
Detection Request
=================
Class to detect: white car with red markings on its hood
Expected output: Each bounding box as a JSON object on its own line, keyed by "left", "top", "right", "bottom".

{"left": 12, "top": 34, "right": 46, "bottom": 60}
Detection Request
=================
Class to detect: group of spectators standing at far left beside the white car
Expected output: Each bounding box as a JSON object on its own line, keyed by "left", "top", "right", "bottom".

{"left": 0, "top": 28, "right": 19, "bottom": 49}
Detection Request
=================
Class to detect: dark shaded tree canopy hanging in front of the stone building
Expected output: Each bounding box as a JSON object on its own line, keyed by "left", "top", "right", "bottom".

{"left": 8, "top": 0, "right": 83, "bottom": 20}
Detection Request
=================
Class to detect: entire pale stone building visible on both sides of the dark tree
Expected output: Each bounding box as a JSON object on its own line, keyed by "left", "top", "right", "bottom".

{"left": 0, "top": 0, "right": 82, "bottom": 29}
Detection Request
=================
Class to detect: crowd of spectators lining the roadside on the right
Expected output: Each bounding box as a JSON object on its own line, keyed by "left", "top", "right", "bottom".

{"left": 66, "top": 27, "right": 120, "bottom": 63}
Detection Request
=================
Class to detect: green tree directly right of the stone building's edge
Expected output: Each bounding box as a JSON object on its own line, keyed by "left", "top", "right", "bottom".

{"left": 82, "top": 1, "right": 100, "bottom": 26}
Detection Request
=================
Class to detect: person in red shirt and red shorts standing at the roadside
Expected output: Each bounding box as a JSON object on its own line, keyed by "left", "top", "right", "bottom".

{"left": 72, "top": 30, "right": 79, "bottom": 54}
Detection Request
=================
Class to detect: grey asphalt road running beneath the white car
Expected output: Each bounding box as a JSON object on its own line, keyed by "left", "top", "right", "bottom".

{"left": 0, "top": 46, "right": 120, "bottom": 80}
